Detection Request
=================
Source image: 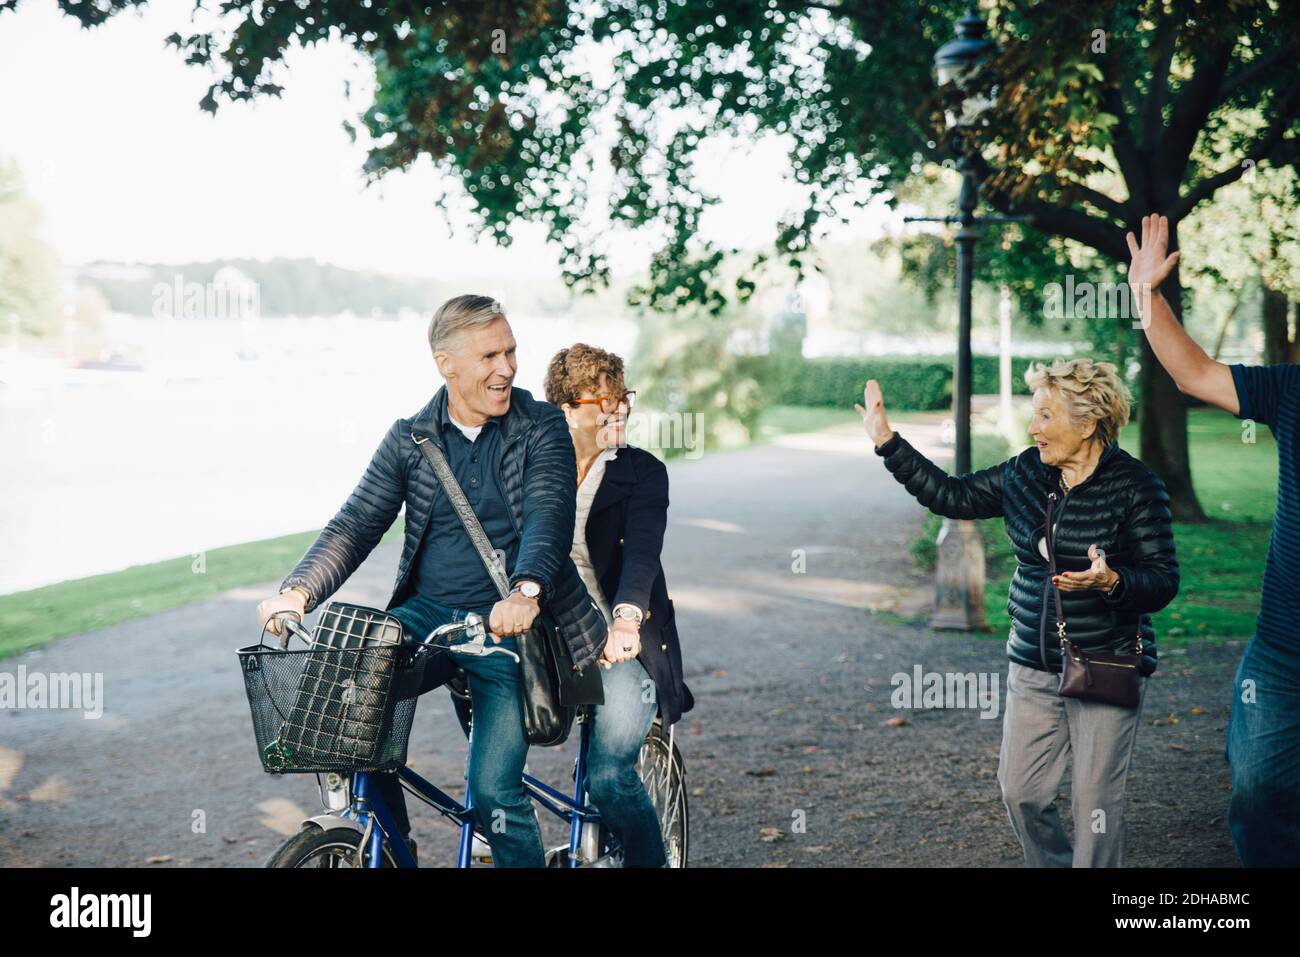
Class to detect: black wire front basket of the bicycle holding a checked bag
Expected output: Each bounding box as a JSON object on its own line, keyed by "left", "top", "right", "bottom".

{"left": 237, "top": 602, "right": 417, "bottom": 774}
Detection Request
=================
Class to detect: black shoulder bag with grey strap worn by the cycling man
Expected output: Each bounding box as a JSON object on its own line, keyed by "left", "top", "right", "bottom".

{"left": 411, "top": 434, "right": 605, "bottom": 748}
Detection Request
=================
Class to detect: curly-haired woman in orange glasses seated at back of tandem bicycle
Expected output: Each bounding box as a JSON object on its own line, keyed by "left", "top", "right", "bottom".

{"left": 546, "top": 343, "right": 694, "bottom": 867}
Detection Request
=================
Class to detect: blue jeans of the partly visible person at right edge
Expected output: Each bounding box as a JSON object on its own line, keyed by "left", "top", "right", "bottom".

{"left": 1227, "top": 636, "right": 1300, "bottom": 867}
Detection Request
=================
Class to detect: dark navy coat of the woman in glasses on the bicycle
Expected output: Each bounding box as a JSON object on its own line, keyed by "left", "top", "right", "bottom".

{"left": 586, "top": 446, "right": 694, "bottom": 727}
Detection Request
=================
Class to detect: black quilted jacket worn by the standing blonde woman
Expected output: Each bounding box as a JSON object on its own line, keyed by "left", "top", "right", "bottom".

{"left": 876, "top": 432, "right": 1179, "bottom": 675}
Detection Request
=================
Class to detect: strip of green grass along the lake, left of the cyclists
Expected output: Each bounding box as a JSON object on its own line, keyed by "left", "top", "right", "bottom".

{"left": 0, "top": 521, "right": 403, "bottom": 658}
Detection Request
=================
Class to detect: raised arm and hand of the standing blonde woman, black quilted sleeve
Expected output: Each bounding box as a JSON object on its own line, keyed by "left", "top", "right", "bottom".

{"left": 854, "top": 378, "right": 1006, "bottom": 519}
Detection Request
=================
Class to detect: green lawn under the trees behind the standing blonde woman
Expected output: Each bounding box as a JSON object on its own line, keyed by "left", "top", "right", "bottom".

{"left": 913, "top": 408, "right": 1278, "bottom": 645}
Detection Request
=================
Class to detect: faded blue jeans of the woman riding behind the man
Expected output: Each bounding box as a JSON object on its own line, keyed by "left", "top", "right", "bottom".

{"left": 586, "top": 659, "right": 667, "bottom": 867}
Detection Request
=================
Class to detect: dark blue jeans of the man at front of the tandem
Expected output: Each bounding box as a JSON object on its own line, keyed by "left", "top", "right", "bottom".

{"left": 374, "top": 596, "right": 546, "bottom": 867}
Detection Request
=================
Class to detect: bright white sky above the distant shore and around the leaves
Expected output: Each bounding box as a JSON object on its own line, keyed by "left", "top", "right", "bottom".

{"left": 0, "top": 0, "right": 884, "bottom": 277}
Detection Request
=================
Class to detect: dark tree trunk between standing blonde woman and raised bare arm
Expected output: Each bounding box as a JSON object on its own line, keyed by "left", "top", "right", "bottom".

{"left": 1138, "top": 239, "right": 1206, "bottom": 521}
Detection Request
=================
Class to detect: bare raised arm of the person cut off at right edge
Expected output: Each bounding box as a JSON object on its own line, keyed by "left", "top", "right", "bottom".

{"left": 1125, "top": 216, "right": 1240, "bottom": 415}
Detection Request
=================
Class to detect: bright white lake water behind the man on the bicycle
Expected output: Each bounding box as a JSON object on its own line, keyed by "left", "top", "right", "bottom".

{"left": 0, "top": 310, "right": 637, "bottom": 594}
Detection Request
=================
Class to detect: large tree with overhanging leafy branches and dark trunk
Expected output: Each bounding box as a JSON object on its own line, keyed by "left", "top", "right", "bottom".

{"left": 15, "top": 0, "right": 1300, "bottom": 519}
